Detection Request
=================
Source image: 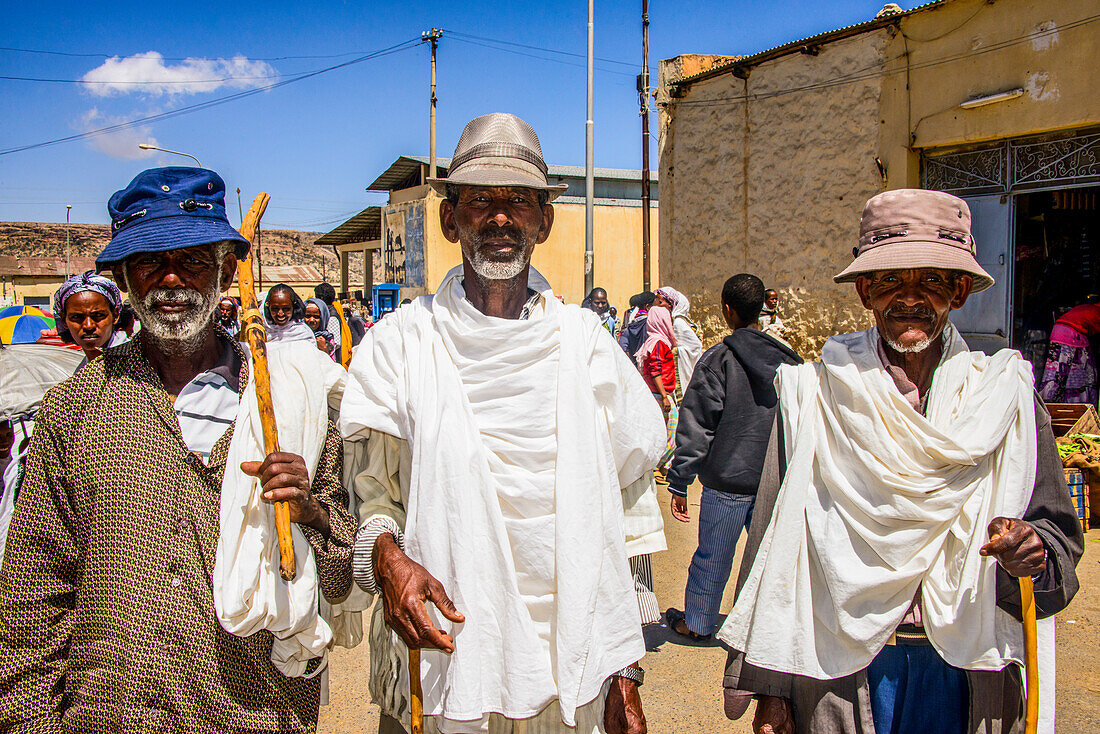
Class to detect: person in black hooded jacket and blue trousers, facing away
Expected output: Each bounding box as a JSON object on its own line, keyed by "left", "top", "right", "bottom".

{"left": 658, "top": 273, "right": 802, "bottom": 639}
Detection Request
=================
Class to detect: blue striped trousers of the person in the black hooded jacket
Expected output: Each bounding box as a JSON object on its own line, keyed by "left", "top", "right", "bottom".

{"left": 684, "top": 486, "right": 756, "bottom": 635}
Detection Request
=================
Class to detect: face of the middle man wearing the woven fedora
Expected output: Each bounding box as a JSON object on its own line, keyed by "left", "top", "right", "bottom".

{"left": 439, "top": 186, "right": 553, "bottom": 281}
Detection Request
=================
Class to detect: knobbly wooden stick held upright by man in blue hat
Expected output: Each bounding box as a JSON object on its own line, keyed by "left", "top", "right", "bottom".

{"left": 237, "top": 194, "right": 296, "bottom": 581}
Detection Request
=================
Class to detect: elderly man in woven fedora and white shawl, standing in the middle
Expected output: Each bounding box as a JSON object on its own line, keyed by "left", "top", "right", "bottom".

{"left": 341, "top": 113, "right": 666, "bottom": 734}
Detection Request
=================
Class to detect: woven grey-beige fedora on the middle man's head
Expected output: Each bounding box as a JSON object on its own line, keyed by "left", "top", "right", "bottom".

{"left": 428, "top": 112, "right": 569, "bottom": 201}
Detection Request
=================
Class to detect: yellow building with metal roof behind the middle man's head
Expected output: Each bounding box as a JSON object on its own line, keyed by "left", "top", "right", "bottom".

{"left": 317, "top": 156, "right": 659, "bottom": 313}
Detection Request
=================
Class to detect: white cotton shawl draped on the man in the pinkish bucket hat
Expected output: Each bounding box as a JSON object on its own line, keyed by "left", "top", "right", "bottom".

{"left": 718, "top": 326, "right": 1036, "bottom": 680}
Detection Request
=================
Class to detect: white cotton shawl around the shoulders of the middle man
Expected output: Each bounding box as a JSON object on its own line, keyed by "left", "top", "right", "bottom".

{"left": 341, "top": 267, "right": 666, "bottom": 726}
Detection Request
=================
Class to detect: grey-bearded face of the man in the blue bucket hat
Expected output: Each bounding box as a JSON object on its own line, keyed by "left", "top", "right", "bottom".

{"left": 112, "top": 244, "right": 237, "bottom": 341}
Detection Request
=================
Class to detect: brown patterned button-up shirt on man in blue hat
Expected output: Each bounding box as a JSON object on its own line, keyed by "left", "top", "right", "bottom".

{"left": 0, "top": 340, "right": 355, "bottom": 734}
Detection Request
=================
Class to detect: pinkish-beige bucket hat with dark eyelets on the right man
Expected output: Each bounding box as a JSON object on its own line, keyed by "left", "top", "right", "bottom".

{"left": 833, "top": 188, "right": 993, "bottom": 293}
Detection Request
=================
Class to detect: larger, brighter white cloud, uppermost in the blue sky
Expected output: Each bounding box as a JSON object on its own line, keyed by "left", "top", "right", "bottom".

{"left": 84, "top": 51, "right": 278, "bottom": 97}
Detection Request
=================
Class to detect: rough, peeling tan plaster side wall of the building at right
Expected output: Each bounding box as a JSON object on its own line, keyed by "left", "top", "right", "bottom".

{"left": 658, "top": 29, "right": 889, "bottom": 358}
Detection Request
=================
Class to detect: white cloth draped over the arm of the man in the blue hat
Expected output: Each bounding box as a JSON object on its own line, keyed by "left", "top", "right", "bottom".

{"left": 213, "top": 341, "right": 347, "bottom": 677}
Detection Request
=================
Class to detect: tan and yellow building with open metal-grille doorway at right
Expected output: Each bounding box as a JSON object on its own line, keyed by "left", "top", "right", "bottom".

{"left": 658, "top": 0, "right": 1100, "bottom": 360}
